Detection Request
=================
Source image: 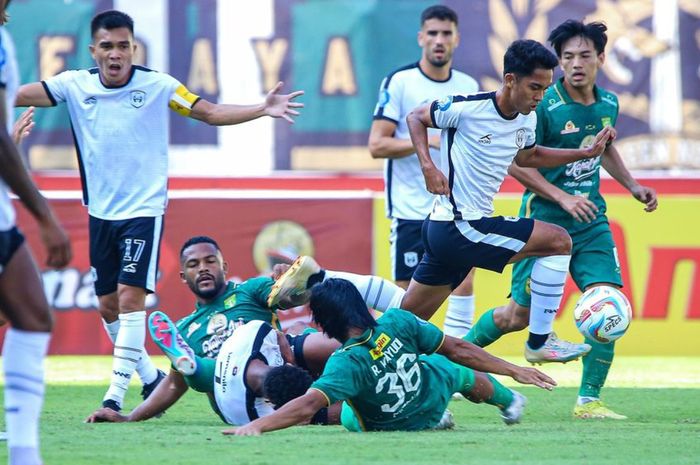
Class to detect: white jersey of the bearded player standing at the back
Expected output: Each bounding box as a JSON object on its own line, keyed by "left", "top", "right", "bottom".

{"left": 374, "top": 63, "right": 479, "bottom": 220}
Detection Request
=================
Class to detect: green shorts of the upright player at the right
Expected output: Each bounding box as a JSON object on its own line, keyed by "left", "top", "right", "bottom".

{"left": 510, "top": 221, "right": 622, "bottom": 307}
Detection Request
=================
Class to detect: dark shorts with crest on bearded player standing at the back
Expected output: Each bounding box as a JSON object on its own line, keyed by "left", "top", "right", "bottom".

{"left": 389, "top": 218, "right": 425, "bottom": 281}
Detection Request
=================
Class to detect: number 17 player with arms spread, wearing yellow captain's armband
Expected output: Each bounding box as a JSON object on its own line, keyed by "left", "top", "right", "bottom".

{"left": 17, "top": 11, "right": 303, "bottom": 410}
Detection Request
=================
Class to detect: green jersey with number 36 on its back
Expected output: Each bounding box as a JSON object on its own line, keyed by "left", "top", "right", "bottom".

{"left": 311, "top": 308, "right": 457, "bottom": 431}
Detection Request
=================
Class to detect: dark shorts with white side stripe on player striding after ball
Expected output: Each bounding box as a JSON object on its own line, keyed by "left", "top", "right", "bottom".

{"left": 413, "top": 216, "right": 535, "bottom": 289}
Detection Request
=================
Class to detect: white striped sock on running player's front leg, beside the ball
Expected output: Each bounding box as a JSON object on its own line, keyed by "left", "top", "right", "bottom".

{"left": 530, "top": 255, "right": 571, "bottom": 334}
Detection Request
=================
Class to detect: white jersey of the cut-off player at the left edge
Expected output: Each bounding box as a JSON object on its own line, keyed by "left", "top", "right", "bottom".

{"left": 0, "top": 27, "right": 19, "bottom": 231}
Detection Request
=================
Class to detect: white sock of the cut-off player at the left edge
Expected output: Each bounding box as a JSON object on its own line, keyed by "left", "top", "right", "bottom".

{"left": 2, "top": 328, "right": 51, "bottom": 465}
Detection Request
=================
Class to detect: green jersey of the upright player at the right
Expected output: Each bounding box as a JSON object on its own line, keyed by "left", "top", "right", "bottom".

{"left": 520, "top": 79, "right": 618, "bottom": 233}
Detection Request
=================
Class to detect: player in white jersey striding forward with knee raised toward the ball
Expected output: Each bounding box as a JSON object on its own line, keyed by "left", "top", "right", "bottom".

{"left": 402, "top": 40, "right": 615, "bottom": 362}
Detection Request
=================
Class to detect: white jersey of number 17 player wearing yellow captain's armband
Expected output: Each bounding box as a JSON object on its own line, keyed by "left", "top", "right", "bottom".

{"left": 43, "top": 66, "right": 197, "bottom": 220}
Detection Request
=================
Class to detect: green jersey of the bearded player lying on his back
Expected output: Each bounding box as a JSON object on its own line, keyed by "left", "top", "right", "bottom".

{"left": 177, "top": 277, "right": 279, "bottom": 358}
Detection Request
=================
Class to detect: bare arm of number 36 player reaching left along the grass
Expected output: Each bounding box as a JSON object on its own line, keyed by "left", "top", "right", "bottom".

{"left": 222, "top": 389, "right": 328, "bottom": 436}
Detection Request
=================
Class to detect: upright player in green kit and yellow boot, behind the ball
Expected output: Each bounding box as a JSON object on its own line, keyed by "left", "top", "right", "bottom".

{"left": 467, "top": 20, "right": 658, "bottom": 419}
